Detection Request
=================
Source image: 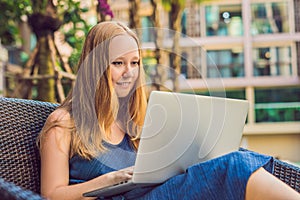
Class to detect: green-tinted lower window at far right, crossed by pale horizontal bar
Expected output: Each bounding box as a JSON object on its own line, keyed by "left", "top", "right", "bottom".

{"left": 255, "top": 87, "right": 300, "bottom": 122}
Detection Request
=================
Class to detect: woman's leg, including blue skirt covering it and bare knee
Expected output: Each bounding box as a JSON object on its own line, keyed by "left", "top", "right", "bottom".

{"left": 128, "top": 151, "right": 300, "bottom": 200}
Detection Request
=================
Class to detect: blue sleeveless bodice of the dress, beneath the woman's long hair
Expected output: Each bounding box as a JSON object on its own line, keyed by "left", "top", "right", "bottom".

{"left": 69, "top": 134, "right": 136, "bottom": 184}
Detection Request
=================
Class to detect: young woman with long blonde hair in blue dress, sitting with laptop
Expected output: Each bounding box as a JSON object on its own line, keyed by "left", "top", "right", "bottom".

{"left": 39, "top": 22, "right": 300, "bottom": 200}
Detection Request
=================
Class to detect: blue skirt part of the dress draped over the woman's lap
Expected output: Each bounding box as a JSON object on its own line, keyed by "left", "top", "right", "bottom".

{"left": 113, "top": 151, "right": 273, "bottom": 200}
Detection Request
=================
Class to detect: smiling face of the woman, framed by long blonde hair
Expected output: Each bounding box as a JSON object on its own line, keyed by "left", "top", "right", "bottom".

{"left": 109, "top": 34, "right": 140, "bottom": 97}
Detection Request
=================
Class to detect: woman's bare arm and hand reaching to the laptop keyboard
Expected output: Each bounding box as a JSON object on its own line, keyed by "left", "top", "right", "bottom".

{"left": 41, "top": 111, "right": 132, "bottom": 200}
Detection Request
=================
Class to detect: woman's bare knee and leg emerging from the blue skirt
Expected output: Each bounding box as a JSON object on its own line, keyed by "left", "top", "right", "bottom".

{"left": 245, "top": 168, "right": 300, "bottom": 200}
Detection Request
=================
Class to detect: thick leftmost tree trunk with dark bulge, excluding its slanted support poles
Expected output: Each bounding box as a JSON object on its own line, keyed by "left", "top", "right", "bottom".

{"left": 28, "top": 0, "right": 61, "bottom": 102}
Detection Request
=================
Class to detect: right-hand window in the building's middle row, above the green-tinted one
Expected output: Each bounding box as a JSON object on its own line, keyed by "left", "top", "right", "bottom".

{"left": 253, "top": 47, "right": 292, "bottom": 76}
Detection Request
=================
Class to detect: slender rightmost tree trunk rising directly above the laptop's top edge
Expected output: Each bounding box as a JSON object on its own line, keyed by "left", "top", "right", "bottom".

{"left": 170, "top": 2, "right": 183, "bottom": 92}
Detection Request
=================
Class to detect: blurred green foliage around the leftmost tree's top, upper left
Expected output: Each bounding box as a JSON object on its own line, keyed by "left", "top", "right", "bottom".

{"left": 0, "top": 0, "right": 91, "bottom": 70}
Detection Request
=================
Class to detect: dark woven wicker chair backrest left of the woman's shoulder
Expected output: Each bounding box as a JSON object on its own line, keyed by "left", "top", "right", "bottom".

{"left": 0, "top": 98, "right": 57, "bottom": 193}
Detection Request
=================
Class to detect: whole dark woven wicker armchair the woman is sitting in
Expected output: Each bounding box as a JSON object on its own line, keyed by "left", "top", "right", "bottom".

{"left": 0, "top": 98, "right": 300, "bottom": 199}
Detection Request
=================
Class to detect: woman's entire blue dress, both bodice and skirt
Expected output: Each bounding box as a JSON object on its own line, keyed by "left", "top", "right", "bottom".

{"left": 70, "top": 135, "right": 273, "bottom": 200}
